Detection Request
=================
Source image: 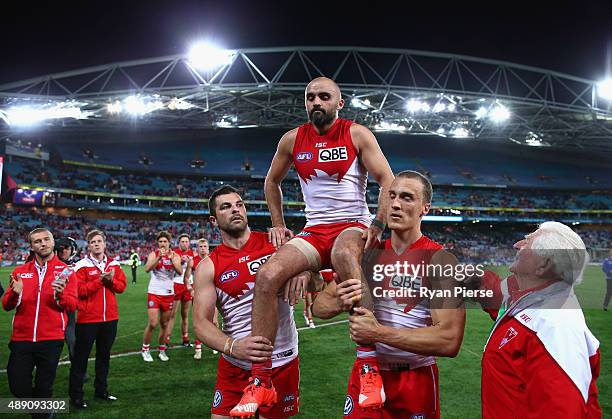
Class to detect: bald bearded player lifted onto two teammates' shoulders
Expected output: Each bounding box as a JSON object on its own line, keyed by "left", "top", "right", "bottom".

{"left": 232, "top": 77, "right": 393, "bottom": 417}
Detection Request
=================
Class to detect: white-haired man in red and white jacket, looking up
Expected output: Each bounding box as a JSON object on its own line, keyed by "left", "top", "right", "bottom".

{"left": 482, "top": 222, "right": 602, "bottom": 419}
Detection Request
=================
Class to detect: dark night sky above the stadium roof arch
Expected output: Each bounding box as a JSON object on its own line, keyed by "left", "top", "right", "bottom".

{"left": 0, "top": 0, "right": 612, "bottom": 83}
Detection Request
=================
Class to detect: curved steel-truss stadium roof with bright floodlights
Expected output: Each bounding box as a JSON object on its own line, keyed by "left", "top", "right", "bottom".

{"left": 0, "top": 47, "right": 612, "bottom": 152}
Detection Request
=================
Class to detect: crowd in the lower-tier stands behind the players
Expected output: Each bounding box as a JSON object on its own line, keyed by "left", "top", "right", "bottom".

{"left": 0, "top": 205, "right": 612, "bottom": 265}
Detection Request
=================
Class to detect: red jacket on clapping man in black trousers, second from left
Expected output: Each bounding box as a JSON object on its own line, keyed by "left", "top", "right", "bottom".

{"left": 74, "top": 256, "right": 126, "bottom": 323}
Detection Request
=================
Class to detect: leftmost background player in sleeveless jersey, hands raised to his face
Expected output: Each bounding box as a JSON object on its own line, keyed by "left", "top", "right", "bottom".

{"left": 142, "top": 231, "right": 182, "bottom": 362}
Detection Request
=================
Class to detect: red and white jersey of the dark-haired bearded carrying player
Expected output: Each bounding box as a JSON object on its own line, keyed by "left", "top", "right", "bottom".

{"left": 210, "top": 231, "right": 298, "bottom": 370}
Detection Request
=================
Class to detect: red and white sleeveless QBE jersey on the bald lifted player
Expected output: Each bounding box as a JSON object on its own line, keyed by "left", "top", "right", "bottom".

{"left": 293, "top": 118, "right": 372, "bottom": 227}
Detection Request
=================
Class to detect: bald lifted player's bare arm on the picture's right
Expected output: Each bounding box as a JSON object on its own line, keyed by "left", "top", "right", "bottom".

{"left": 351, "top": 124, "right": 395, "bottom": 248}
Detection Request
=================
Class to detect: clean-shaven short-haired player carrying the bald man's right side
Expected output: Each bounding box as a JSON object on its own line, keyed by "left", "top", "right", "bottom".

{"left": 313, "top": 171, "right": 465, "bottom": 419}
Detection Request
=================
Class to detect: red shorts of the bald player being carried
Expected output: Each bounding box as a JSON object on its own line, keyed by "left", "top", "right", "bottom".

{"left": 294, "top": 221, "right": 368, "bottom": 269}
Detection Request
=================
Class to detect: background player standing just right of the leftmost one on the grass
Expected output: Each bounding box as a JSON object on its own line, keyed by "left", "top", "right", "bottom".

{"left": 166, "top": 234, "right": 193, "bottom": 347}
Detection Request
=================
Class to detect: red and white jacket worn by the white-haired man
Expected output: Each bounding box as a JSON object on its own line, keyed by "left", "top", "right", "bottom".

{"left": 482, "top": 281, "right": 602, "bottom": 419}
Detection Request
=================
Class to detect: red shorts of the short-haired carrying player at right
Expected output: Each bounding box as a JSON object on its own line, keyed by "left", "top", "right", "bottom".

{"left": 344, "top": 364, "right": 440, "bottom": 419}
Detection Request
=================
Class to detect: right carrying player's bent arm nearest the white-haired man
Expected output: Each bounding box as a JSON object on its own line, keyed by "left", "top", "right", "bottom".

{"left": 349, "top": 251, "right": 465, "bottom": 357}
